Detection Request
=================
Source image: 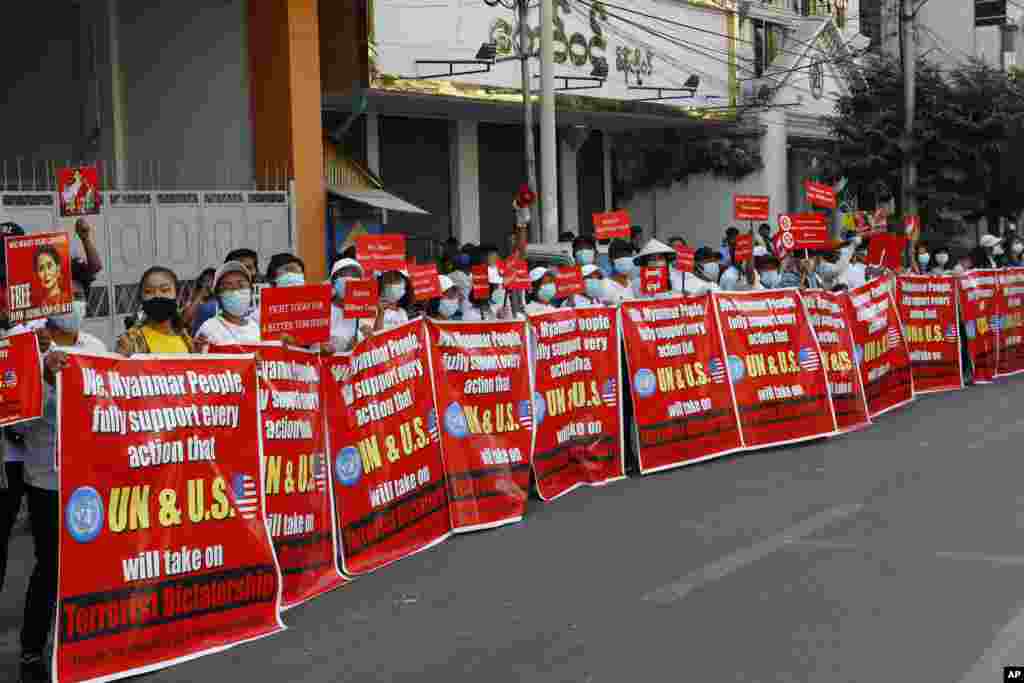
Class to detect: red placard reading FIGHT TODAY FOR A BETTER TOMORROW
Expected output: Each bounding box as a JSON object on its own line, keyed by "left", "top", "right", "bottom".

{"left": 259, "top": 284, "right": 331, "bottom": 346}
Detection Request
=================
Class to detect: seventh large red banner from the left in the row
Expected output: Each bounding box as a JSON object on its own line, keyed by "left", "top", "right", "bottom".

{"left": 713, "top": 289, "right": 837, "bottom": 447}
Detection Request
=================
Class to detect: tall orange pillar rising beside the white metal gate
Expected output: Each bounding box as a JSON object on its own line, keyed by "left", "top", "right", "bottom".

{"left": 249, "top": 0, "right": 327, "bottom": 282}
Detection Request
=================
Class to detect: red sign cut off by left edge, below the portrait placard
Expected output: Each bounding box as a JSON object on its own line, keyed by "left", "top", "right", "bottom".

{"left": 0, "top": 332, "right": 43, "bottom": 427}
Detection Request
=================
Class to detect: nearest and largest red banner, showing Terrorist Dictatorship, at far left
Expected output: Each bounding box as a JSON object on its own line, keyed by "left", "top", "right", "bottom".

{"left": 54, "top": 353, "right": 285, "bottom": 681}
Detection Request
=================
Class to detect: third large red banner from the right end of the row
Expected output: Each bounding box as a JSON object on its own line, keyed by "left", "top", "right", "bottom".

{"left": 896, "top": 275, "right": 964, "bottom": 393}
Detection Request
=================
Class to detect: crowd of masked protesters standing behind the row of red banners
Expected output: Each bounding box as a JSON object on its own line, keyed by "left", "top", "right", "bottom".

{"left": 0, "top": 211, "right": 1024, "bottom": 683}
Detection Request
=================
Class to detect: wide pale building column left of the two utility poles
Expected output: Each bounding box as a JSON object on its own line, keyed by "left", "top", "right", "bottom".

{"left": 449, "top": 121, "right": 479, "bottom": 245}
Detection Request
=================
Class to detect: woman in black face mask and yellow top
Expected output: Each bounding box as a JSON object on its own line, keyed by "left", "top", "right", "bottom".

{"left": 116, "top": 265, "right": 193, "bottom": 355}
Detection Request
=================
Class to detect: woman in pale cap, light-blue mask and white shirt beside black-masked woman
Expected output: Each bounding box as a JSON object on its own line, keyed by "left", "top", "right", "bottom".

{"left": 196, "top": 261, "right": 259, "bottom": 353}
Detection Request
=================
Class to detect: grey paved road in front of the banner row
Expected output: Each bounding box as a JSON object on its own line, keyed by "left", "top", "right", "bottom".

{"left": 0, "top": 380, "right": 1024, "bottom": 683}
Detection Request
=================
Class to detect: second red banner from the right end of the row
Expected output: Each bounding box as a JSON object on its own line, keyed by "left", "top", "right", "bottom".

{"left": 956, "top": 270, "right": 999, "bottom": 383}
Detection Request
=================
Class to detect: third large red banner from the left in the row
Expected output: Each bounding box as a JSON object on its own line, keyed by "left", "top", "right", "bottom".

{"left": 323, "top": 321, "right": 452, "bottom": 575}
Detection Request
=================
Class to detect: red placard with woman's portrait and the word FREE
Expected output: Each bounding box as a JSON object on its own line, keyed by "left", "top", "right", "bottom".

{"left": 4, "top": 232, "right": 74, "bottom": 325}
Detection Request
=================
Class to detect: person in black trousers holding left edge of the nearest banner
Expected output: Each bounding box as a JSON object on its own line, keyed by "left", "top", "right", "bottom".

{"left": 7, "top": 261, "right": 106, "bottom": 683}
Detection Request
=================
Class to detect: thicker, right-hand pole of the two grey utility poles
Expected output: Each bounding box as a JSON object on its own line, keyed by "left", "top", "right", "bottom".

{"left": 541, "top": 0, "right": 558, "bottom": 244}
